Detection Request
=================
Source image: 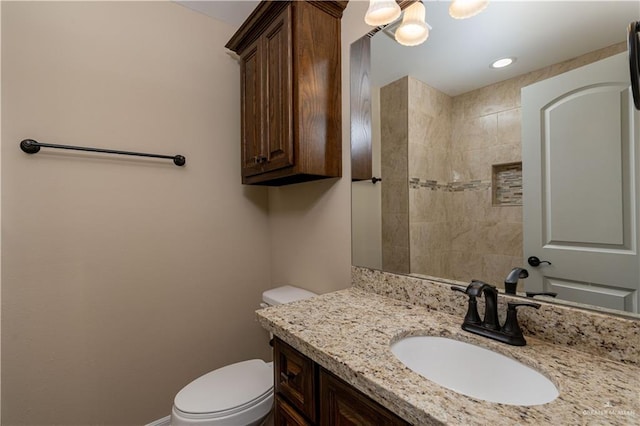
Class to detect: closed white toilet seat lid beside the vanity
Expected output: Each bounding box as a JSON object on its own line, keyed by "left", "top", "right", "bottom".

{"left": 174, "top": 359, "right": 273, "bottom": 414}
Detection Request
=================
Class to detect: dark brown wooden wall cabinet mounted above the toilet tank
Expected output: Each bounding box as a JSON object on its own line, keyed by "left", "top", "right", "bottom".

{"left": 226, "top": 1, "right": 347, "bottom": 186}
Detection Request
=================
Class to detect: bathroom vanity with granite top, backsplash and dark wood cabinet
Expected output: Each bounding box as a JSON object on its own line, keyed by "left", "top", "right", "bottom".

{"left": 257, "top": 268, "right": 640, "bottom": 425}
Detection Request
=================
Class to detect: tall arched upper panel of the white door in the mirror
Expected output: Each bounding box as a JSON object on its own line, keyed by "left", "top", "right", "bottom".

{"left": 542, "top": 84, "right": 630, "bottom": 248}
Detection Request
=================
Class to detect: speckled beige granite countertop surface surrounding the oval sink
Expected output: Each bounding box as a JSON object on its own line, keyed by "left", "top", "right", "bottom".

{"left": 257, "top": 288, "right": 640, "bottom": 425}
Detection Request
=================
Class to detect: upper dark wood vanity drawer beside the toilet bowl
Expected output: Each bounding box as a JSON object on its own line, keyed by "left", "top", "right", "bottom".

{"left": 273, "top": 339, "right": 317, "bottom": 423}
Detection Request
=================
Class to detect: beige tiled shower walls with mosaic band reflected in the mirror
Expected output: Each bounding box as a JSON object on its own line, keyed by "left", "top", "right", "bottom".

{"left": 380, "top": 43, "right": 626, "bottom": 286}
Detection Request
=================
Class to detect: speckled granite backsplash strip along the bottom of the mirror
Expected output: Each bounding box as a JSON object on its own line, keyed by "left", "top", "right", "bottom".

{"left": 351, "top": 266, "right": 640, "bottom": 365}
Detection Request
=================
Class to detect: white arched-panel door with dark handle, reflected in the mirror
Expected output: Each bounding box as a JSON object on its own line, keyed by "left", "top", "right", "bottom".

{"left": 522, "top": 53, "right": 640, "bottom": 312}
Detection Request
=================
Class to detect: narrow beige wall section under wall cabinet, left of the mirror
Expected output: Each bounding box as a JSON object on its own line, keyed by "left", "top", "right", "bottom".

{"left": 269, "top": 0, "right": 370, "bottom": 293}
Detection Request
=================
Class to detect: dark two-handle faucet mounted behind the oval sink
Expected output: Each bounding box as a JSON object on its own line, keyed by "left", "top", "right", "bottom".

{"left": 451, "top": 280, "right": 540, "bottom": 346}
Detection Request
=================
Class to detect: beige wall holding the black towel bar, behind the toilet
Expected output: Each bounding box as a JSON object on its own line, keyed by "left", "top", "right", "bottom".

{"left": 2, "top": 2, "right": 272, "bottom": 425}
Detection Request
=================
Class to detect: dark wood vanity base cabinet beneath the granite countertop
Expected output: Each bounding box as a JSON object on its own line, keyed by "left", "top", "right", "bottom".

{"left": 273, "top": 338, "right": 409, "bottom": 426}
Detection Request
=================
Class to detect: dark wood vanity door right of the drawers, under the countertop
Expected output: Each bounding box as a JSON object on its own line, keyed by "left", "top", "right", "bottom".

{"left": 320, "top": 370, "right": 409, "bottom": 426}
